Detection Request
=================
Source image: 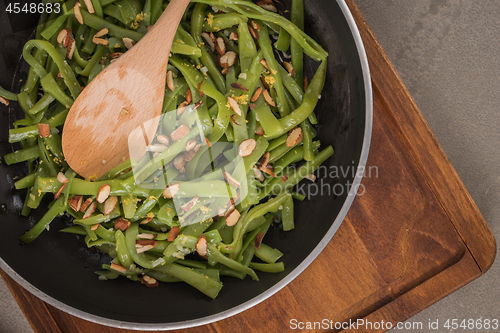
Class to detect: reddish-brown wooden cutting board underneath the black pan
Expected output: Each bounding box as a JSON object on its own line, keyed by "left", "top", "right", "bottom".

{"left": 1, "top": 0, "right": 496, "bottom": 333}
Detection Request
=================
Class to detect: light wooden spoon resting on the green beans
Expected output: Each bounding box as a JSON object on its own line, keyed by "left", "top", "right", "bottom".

{"left": 62, "top": 0, "right": 189, "bottom": 179}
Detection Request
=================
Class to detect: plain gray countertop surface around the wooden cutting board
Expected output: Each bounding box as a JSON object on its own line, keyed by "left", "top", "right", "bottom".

{"left": 0, "top": 0, "right": 500, "bottom": 333}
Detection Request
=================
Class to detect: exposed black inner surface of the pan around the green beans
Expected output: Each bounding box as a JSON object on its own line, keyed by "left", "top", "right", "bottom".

{"left": 0, "top": 0, "right": 369, "bottom": 328}
